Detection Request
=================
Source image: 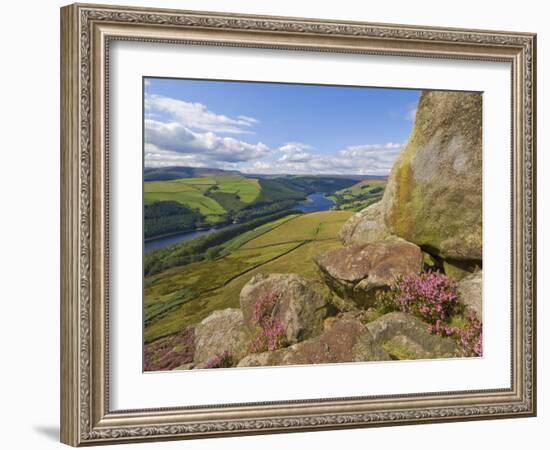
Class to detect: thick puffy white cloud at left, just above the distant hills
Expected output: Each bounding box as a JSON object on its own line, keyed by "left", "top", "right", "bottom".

{"left": 145, "top": 119, "right": 269, "bottom": 165}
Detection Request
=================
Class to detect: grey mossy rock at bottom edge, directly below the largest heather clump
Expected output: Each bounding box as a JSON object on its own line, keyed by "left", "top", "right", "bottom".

{"left": 366, "top": 312, "right": 459, "bottom": 359}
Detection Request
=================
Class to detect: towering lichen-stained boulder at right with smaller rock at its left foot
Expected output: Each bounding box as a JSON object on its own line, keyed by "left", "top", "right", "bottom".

{"left": 340, "top": 91, "right": 482, "bottom": 261}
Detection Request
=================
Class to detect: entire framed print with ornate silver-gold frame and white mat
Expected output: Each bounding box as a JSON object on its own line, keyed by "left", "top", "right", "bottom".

{"left": 61, "top": 4, "right": 536, "bottom": 446}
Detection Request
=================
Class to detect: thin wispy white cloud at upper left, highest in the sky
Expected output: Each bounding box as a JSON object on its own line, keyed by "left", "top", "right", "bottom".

{"left": 145, "top": 94, "right": 258, "bottom": 134}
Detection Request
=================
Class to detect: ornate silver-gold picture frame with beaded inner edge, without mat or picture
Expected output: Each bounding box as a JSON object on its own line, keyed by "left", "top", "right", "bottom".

{"left": 61, "top": 4, "right": 536, "bottom": 446}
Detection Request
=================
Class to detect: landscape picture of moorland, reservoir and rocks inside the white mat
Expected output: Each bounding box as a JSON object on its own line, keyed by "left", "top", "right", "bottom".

{"left": 142, "top": 77, "right": 483, "bottom": 372}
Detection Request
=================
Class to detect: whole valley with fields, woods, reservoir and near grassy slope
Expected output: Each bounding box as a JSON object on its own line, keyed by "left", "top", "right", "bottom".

{"left": 143, "top": 168, "right": 385, "bottom": 350}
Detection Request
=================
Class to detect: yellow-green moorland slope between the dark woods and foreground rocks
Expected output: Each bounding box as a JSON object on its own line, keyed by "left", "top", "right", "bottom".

{"left": 144, "top": 211, "right": 352, "bottom": 342}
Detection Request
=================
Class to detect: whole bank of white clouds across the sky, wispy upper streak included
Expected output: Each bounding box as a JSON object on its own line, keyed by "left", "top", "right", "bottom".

{"left": 144, "top": 94, "right": 403, "bottom": 175}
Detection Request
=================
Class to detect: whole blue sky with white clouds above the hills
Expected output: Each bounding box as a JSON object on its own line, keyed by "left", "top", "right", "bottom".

{"left": 144, "top": 78, "right": 420, "bottom": 175}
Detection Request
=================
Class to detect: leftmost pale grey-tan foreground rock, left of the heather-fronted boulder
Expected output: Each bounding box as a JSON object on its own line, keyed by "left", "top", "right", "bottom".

{"left": 193, "top": 308, "right": 251, "bottom": 367}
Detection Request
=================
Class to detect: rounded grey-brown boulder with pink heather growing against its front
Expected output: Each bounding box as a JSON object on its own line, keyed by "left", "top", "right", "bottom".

{"left": 240, "top": 273, "right": 331, "bottom": 344}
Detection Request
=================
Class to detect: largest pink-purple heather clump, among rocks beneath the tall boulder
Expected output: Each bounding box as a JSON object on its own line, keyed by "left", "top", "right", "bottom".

{"left": 390, "top": 272, "right": 460, "bottom": 325}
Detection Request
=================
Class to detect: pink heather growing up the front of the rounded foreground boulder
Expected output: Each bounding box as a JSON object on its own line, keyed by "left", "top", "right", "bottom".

{"left": 251, "top": 294, "right": 286, "bottom": 353}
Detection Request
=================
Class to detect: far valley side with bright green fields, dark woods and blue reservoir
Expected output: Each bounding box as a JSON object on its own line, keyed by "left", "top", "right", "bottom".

{"left": 144, "top": 167, "right": 364, "bottom": 239}
